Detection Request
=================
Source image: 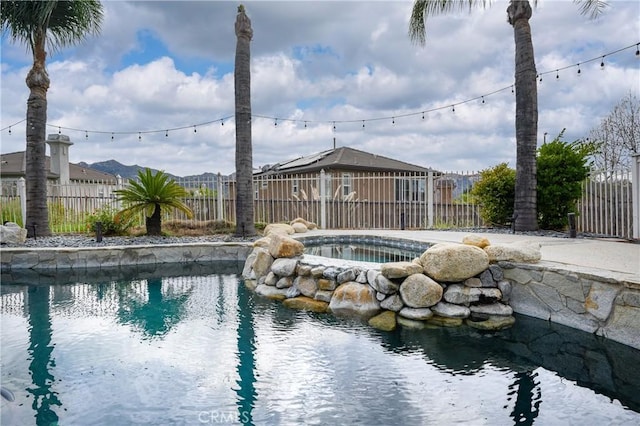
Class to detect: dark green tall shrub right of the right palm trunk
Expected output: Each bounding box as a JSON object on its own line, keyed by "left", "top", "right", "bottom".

{"left": 537, "top": 130, "right": 591, "bottom": 230}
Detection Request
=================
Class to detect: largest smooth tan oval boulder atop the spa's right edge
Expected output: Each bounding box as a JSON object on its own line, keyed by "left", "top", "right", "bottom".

{"left": 420, "top": 243, "right": 493, "bottom": 282}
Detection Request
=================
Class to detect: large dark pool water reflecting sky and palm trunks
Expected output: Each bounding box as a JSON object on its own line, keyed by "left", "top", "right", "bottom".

{"left": 0, "top": 264, "right": 640, "bottom": 425}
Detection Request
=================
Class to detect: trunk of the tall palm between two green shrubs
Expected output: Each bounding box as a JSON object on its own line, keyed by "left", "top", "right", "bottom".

{"left": 507, "top": 0, "right": 538, "bottom": 231}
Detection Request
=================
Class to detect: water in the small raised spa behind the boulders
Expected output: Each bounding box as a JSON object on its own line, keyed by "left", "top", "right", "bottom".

{"left": 304, "top": 243, "right": 424, "bottom": 263}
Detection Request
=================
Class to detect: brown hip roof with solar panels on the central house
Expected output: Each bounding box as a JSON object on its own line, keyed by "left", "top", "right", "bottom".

{"left": 256, "top": 147, "right": 432, "bottom": 175}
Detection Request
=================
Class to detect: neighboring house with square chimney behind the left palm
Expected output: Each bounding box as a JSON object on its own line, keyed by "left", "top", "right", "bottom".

{"left": 0, "top": 134, "right": 117, "bottom": 198}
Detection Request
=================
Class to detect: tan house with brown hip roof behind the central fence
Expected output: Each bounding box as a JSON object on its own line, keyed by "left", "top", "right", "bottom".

{"left": 254, "top": 147, "right": 455, "bottom": 203}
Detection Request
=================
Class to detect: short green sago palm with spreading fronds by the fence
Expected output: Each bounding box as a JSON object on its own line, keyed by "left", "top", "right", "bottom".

{"left": 115, "top": 168, "right": 193, "bottom": 235}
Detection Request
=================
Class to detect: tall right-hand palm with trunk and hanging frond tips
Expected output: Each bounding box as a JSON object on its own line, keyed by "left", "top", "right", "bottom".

{"left": 409, "top": 0, "right": 607, "bottom": 231}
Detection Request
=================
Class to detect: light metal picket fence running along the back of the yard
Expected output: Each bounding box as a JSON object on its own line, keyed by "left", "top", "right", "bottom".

{"left": 0, "top": 167, "right": 633, "bottom": 239}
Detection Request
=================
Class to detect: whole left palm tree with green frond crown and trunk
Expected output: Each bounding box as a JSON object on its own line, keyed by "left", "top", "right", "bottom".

{"left": 0, "top": 0, "right": 102, "bottom": 237}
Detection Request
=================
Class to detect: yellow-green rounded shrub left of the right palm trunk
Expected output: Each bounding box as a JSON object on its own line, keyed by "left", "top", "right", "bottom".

{"left": 471, "top": 163, "right": 516, "bottom": 225}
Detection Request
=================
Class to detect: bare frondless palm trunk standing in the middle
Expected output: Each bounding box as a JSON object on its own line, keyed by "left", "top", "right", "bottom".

{"left": 234, "top": 5, "right": 256, "bottom": 236}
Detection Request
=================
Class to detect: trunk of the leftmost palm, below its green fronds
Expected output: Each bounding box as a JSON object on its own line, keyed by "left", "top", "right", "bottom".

{"left": 24, "top": 31, "right": 51, "bottom": 238}
